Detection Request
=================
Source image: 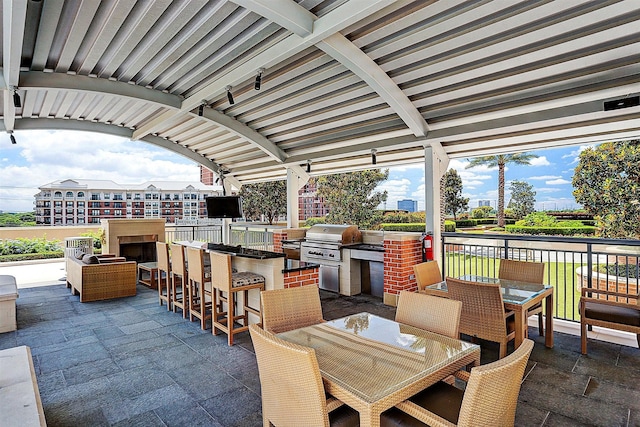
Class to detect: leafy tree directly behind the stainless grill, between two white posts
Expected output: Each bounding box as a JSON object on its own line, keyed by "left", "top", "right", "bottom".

{"left": 318, "top": 169, "right": 389, "bottom": 229}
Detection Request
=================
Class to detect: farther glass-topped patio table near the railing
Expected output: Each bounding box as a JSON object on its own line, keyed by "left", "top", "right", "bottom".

{"left": 425, "top": 275, "right": 553, "bottom": 348}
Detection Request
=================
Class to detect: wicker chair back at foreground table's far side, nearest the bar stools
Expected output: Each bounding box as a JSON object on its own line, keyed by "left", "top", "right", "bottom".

{"left": 260, "top": 285, "right": 324, "bottom": 334}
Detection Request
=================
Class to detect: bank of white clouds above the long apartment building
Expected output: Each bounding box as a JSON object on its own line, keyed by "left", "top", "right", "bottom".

{"left": 0, "top": 131, "right": 200, "bottom": 212}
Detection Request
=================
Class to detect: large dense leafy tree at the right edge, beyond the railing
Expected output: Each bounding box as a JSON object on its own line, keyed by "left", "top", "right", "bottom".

{"left": 573, "top": 140, "right": 640, "bottom": 239}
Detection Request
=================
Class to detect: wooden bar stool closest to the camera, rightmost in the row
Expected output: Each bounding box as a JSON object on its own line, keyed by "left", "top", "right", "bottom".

{"left": 209, "top": 252, "right": 264, "bottom": 346}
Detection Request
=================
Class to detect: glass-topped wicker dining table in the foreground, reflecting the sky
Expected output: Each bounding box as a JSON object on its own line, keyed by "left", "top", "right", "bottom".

{"left": 278, "top": 313, "right": 480, "bottom": 426}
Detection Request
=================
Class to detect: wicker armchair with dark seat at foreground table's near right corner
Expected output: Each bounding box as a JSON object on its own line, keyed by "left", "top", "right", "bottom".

{"left": 380, "top": 339, "right": 533, "bottom": 427}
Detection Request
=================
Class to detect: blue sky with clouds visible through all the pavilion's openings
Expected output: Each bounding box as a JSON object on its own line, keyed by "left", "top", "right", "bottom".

{"left": 0, "top": 131, "right": 585, "bottom": 212}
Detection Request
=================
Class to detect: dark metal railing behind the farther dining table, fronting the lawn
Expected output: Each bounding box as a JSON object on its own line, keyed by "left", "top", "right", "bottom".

{"left": 442, "top": 233, "right": 640, "bottom": 321}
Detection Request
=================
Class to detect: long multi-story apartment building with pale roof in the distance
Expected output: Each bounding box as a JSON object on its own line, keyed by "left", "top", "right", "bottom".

{"left": 35, "top": 179, "right": 222, "bottom": 225}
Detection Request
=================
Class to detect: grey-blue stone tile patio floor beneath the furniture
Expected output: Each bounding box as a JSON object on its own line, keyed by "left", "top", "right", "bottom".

{"left": 0, "top": 284, "right": 640, "bottom": 427}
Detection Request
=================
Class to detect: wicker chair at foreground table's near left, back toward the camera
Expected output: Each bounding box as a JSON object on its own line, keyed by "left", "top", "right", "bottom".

{"left": 249, "top": 324, "right": 360, "bottom": 427}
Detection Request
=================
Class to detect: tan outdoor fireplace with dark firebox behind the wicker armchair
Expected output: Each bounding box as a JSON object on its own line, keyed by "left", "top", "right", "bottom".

{"left": 102, "top": 219, "right": 165, "bottom": 263}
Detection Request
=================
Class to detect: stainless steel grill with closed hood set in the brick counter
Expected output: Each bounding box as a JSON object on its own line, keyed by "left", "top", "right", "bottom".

{"left": 300, "top": 224, "right": 362, "bottom": 292}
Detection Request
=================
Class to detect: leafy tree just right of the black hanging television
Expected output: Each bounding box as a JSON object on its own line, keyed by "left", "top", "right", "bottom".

{"left": 240, "top": 181, "right": 287, "bottom": 224}
